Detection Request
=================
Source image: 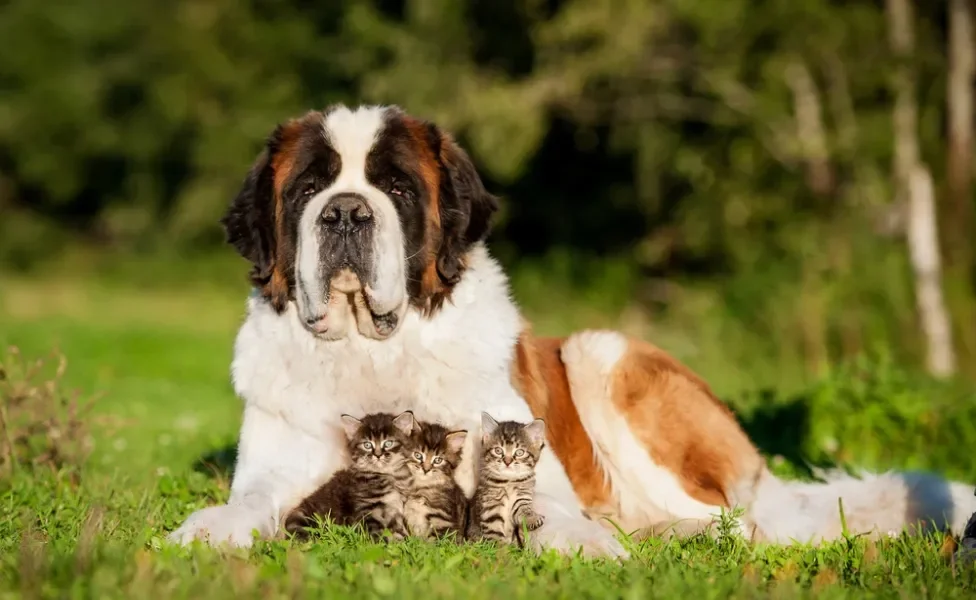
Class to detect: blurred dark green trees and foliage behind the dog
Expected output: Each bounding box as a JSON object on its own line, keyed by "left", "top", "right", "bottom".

{"left": 0, "top": 0, "right": 976, "bottom": 384}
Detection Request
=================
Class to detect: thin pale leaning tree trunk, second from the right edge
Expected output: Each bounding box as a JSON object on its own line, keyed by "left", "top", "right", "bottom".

{"left": 887, "top": 0, "right": 956, "bottom": 377}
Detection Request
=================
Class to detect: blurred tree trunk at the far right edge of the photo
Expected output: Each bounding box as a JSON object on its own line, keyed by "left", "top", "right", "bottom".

{"left": 942, "top": 0, "right": 976, "bottom": 270}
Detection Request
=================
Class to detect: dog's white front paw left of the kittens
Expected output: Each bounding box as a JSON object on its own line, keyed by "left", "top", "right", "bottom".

{"left": 167, "top": 504, "right": 275, "bottom": 548}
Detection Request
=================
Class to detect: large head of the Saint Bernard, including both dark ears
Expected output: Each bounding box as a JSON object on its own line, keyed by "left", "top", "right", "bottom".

{"left": 222, "top": 106, "right": 498, "bottom": 339}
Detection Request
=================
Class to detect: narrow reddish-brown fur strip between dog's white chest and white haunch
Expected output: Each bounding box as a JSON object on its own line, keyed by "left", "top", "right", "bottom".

{"left": 512, "top": 327, "right": 610, "bottom": 509}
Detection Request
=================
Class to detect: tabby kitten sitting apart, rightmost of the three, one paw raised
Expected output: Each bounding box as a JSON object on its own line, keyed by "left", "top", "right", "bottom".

{"left": 466, "top": 413, "right": 546, "bottom": 543}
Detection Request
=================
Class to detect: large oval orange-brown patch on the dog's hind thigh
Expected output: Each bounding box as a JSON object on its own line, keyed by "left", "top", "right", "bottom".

{"left": 612, "top": 340, "right": 764, "bottom": 507}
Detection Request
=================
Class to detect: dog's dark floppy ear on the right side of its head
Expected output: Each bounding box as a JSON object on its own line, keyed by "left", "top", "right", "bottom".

{"left": 428, "top": 124, "right": 498, "bottom": 285}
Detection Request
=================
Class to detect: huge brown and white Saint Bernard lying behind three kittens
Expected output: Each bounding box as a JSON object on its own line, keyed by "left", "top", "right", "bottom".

{"left": 170, "top": 106, "right": 976, "bottom": 557}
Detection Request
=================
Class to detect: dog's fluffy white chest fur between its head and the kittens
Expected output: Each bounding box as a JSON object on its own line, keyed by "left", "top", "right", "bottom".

{"left": 232, "top": 249, "right": 532, "bottom": 501}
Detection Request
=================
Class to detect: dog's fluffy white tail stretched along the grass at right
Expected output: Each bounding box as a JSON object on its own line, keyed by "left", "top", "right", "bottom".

{"left": 745, "top": 471, "right": 976, "bottom": 544}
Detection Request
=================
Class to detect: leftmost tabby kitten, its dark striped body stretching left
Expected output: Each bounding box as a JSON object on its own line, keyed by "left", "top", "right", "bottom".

{"left": 285, "top": 412, "right": 414, "bottom": 539}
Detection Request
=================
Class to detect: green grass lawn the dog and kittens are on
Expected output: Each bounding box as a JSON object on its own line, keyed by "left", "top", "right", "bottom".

{"left": 0, "top": 264, "right": 976, "bottom": 599}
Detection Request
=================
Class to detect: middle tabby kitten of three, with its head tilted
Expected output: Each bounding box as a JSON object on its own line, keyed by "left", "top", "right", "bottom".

{"left": 403, "top": 414, "right": 468, "bottom": 538}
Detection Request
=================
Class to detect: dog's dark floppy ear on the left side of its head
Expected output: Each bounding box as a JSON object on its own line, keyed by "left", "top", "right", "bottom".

{"left": 220, "top": 126, "right": 282, "bottom": 287}
